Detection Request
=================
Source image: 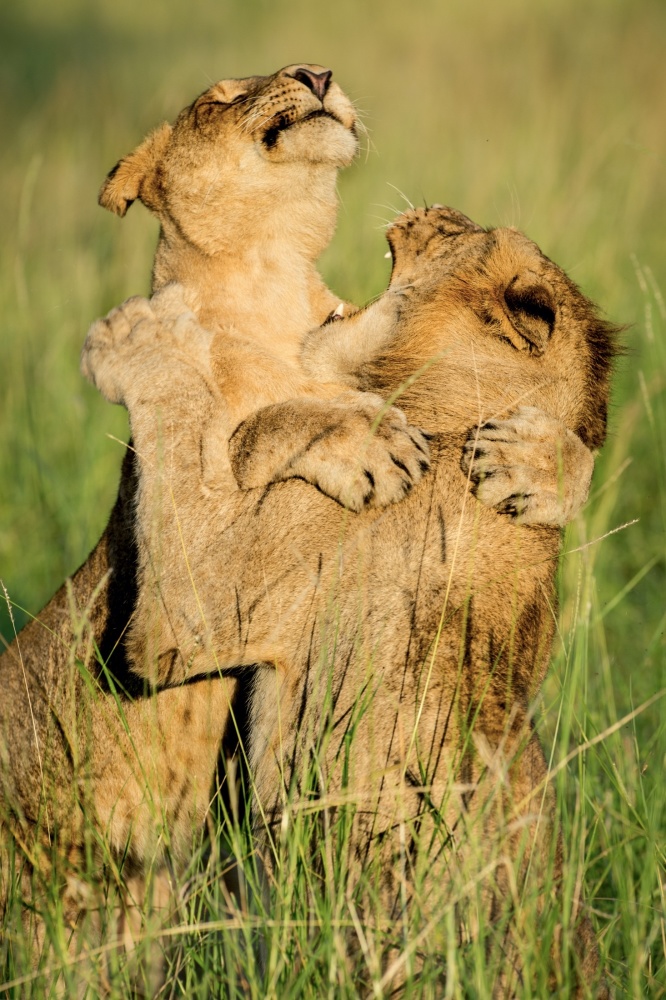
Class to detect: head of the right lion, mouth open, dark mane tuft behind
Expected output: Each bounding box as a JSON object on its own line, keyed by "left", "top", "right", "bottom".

{"left": 387, "top": 206, "right": 615, "bottom": 448}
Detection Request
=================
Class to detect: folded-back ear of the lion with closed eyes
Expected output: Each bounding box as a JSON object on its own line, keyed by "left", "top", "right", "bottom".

{"left": 98, "top": 122, "right": 171, "bottom": 217}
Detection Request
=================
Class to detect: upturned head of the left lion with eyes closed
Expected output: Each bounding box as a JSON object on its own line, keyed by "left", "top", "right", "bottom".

{"left": 99, "top": 64, "right": 358, "bottom": 253}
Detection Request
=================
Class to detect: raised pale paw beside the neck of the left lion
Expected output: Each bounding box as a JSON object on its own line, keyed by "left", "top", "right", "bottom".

{"left": 81, "top": 285, "right": 212, "bottom": 405}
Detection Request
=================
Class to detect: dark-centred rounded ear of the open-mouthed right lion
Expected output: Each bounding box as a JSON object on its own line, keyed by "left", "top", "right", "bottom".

{"left": 503, "top": 271, "right": 556, "bottom": 354}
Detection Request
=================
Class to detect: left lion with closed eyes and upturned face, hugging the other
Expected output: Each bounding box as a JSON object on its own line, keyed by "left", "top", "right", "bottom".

{"left": 0, "top": 66, "right": 591, "bottom": 988}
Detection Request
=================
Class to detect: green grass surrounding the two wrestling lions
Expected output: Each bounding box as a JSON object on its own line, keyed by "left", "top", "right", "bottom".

{"left": 0, "top": 0, "right": 666, "bottom": 997}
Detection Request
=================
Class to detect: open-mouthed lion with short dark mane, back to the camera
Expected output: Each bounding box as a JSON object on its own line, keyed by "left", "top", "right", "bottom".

{"left": 86, "top": 207, "right": 613, "bottom": 997}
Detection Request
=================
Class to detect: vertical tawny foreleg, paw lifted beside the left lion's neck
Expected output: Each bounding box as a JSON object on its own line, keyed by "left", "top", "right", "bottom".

{"left": 81, "top": 290, "right": 237, "bottom": 675}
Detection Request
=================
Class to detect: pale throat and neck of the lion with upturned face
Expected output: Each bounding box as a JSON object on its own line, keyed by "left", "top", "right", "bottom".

{"left": 153, "top": 168, "right": 339, "bottom": 364}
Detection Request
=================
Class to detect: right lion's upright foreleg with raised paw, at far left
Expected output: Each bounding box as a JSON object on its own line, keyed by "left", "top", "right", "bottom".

{"left": 81, "top": 294, "right": 292, "bottom": 686}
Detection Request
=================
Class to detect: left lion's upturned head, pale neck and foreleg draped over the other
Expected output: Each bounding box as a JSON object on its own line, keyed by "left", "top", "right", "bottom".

{"left": 91, "top": 65, "right": 428, "bottom": 510}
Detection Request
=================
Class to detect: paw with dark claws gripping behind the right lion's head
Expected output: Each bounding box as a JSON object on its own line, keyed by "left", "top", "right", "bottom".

{"left": 461, "top": 406, "right": 594, "bottom": 527}
